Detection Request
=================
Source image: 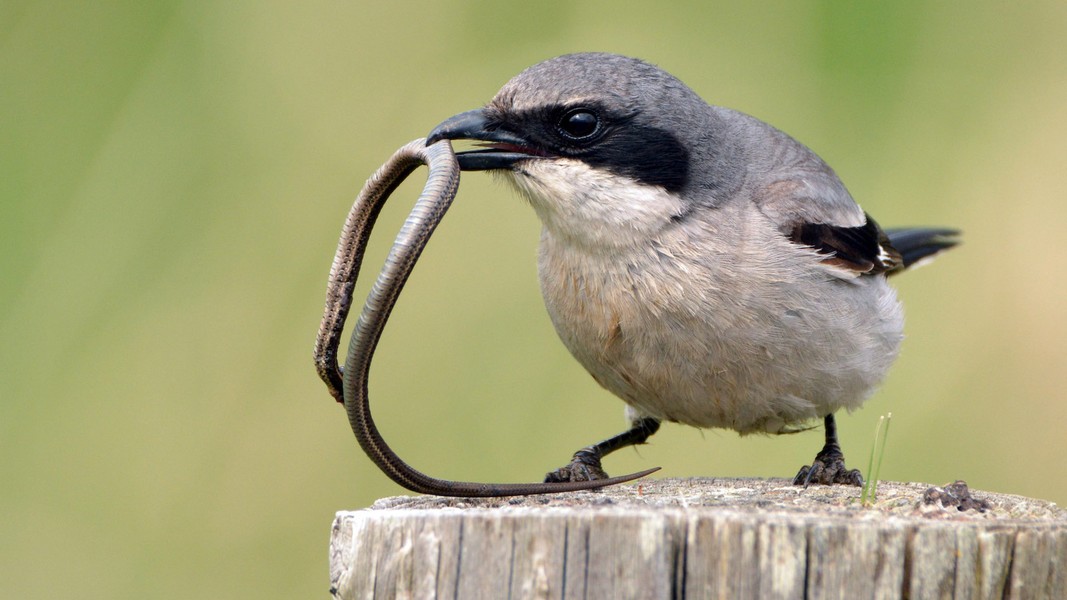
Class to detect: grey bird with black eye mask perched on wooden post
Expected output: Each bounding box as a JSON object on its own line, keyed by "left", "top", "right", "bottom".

{"left": 427, "top": 49, "right": 956, "bottom": 485}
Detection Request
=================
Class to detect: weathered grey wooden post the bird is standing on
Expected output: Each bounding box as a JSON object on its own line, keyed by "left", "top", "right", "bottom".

{"left": 330, "top": 479, "right": 1067, "bottom": 599}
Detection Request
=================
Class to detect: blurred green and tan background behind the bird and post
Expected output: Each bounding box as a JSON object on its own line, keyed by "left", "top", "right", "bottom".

{"left": 0, "top": 0, "right": 1067, "bottom": 598}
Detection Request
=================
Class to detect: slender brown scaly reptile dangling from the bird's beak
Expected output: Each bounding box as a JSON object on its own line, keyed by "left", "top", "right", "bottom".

{"left": 315, "top": 139, "right": 657, "bottom": 496}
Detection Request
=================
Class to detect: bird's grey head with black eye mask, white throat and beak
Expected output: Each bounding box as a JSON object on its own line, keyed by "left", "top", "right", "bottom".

{"left": 427, "top": 53, "right": 734, "bottom": 246}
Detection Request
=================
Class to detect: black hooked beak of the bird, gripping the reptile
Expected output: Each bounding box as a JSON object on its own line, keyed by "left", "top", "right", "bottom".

{"left": 426, "top": 109, "right": 544, "bottom": 171}
